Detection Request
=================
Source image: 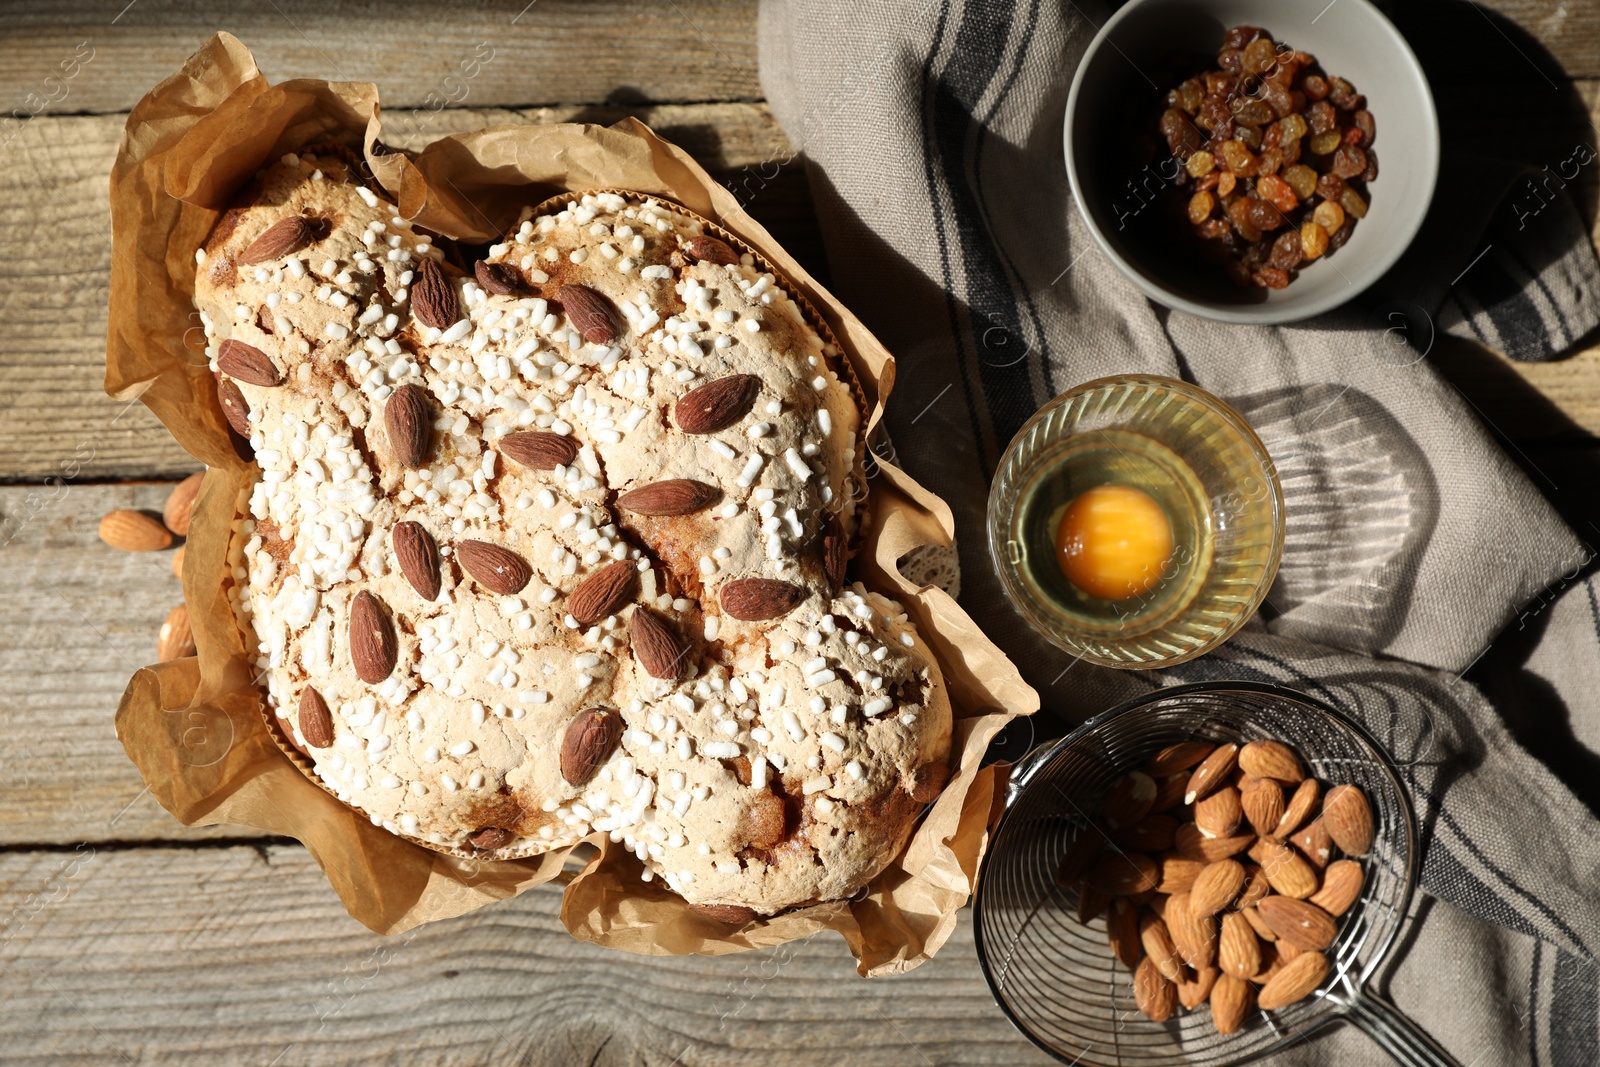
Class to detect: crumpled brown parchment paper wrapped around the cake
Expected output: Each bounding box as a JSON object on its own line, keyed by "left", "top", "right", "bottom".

{"left": 106, "top": 34, "right": 1038, "bottom": 976}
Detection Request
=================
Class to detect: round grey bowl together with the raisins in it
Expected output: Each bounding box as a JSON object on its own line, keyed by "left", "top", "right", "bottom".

{"left": 1064, "top": 0, "right": 1438, "bottom": 323}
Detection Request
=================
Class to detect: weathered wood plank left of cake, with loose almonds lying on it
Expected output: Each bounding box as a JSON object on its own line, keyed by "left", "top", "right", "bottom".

{"left": 0, "top": 483, "right": 268, "bottom": 845}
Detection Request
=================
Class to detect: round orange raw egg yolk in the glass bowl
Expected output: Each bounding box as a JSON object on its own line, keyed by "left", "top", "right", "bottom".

{"left": 1056, "top": 485, "right": 1173, "bottom": 600}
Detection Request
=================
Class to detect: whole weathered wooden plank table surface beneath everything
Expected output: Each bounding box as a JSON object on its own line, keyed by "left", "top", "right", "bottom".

{"left": 0, "top": 0, "right": 1600, "bottom": 1065}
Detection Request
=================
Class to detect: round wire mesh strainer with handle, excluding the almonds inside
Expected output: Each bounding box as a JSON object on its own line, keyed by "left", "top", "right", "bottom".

{"left": 973, "top": 681, "right": 1459, "bottom": 1067}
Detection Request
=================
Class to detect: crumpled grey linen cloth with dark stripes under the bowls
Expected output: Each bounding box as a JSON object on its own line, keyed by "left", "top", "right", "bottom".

{"left": 761, "top": 0, "right": 1600, "bottom": 1067}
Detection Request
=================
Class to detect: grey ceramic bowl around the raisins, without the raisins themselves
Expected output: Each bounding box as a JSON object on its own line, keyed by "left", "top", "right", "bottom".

{"left": 1064, "top": 0, "right": 1438, "bottom": 323}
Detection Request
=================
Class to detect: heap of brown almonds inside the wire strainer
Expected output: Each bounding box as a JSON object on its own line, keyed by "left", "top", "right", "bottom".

{"left": 1056, "top": 741, "right": 1374, "bottom": 1033}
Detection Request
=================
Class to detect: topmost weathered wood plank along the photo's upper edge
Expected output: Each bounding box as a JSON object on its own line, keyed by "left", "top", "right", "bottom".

{"left": 0, "top": 0, "right": 762, "bottom": 117}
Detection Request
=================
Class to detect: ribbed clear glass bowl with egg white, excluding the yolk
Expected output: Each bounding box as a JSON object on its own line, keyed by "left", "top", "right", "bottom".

{"left": 989, "top": 374, "right": 1283, "bottom": 669}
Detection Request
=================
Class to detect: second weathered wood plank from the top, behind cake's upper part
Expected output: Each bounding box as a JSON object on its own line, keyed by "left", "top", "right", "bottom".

{"left": 0, "top": 104, "right": 812, "bottom": 482}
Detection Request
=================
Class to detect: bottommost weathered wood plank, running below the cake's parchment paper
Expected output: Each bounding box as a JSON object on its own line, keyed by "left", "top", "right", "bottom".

{"left": 0, "top": 846, "right": 1050, "bottom": 1067}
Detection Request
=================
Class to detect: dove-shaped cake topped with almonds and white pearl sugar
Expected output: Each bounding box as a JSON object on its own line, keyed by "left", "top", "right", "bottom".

{"left": 195, "top": 154, "right": 950, "bottom": 913}
